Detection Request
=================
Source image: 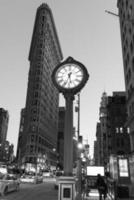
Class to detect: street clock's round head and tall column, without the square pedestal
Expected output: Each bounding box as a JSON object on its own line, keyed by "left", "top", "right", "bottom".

{"left": 52, "top": 57, "right": 89, "bottom": 199}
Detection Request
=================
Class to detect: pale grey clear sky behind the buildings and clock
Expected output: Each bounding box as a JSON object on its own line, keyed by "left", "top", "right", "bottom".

{"left": 0, "top": 0, "right": 125, "bottom": 158}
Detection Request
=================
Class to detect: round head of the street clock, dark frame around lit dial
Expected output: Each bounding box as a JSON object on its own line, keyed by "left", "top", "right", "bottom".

{"left": 52, "top": 57, "right": 89, "bottom": 94}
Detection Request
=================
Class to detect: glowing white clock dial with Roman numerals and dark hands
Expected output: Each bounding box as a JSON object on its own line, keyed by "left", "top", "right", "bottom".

{"left": 55, "top": 63, "right": 84, "bottom": 89}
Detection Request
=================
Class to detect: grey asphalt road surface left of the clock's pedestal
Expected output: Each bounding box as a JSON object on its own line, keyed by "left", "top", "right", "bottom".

{"left": 0, "top": 181, "right": 58, "bottom": 200}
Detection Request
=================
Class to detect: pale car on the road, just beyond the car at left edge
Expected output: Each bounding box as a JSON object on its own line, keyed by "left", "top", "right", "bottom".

{"left": 20, "top": 173, "right": 43, "bottom": 184}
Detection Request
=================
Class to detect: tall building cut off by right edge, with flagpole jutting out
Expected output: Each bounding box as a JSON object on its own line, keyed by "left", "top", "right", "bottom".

{"left": 117, "top": 0, "right": 134, "bottom": 152}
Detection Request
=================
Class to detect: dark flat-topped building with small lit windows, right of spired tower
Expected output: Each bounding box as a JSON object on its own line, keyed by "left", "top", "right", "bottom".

{"left": 107, "top": 92, "right": 130, "bottom": 155}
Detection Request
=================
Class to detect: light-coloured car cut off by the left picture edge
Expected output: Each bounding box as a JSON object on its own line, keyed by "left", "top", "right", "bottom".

{"left": 0, "top": 173, "right": 20, "bottom": 195}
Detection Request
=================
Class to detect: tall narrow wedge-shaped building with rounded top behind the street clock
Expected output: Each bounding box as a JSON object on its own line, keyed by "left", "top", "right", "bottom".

{"left": 18, "top": 3, "right": 62, "bottom": 170}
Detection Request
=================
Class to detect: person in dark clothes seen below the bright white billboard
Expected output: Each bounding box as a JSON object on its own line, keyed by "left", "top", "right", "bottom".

{"left": 96, "top": 174, "right": 107, "bottom": 200}
